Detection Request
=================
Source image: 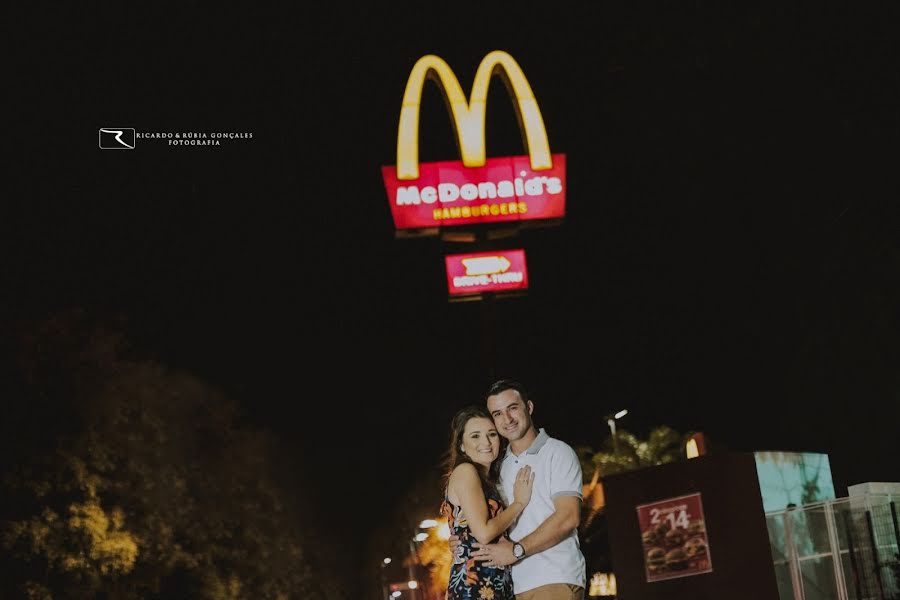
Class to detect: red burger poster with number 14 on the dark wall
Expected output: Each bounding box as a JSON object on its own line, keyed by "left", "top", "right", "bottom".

{"left": 637, "top": 494, "right": 712, "bottom": 582}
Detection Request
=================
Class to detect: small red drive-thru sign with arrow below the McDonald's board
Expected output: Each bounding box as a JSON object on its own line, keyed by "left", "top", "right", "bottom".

{"left": 444, "top": 250, "right": 528, "bottom": 296}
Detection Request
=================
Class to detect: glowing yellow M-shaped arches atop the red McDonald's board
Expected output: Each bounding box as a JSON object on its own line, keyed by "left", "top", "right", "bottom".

{"left": 397, "top": 50, "right": 553, "bottom": 180}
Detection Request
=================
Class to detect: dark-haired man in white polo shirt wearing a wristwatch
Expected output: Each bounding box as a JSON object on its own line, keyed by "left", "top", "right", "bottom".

{"left": 454, "top": 379, "right": 585, "bottom": 600}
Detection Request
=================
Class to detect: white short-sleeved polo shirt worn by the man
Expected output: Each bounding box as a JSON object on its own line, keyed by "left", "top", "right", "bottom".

{"left": 500, "top": 429, "right": 585, "bottom": 594}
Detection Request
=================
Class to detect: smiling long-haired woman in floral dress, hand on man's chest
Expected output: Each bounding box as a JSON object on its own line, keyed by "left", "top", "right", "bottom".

{"left": 441, "top": 406, "right": 534, "bottom": 600}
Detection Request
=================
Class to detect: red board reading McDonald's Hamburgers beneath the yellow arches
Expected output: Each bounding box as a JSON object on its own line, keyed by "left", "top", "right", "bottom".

{"left": 381, "top": 154, "right": 566, "bottom": 229}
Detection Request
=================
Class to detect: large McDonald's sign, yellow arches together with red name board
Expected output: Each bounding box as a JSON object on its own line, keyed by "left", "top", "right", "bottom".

{"left": 382, "top": 50, "right": 566, "bottom": 232}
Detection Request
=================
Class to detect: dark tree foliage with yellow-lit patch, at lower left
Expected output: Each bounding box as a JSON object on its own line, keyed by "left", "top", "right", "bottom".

{"left": 0, "top": 315, "right": 333, "bottom": 600}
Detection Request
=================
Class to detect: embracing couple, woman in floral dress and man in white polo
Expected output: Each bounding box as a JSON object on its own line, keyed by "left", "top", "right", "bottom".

{"left": 442, "top": 379, "right": 585, "bottom": 600}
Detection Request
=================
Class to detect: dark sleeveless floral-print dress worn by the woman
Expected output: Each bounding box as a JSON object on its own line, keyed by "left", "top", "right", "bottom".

{"left": 441, "top": 494, "right": 515, "bottom": 600}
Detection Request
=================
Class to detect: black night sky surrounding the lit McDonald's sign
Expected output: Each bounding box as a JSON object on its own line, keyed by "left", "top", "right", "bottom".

{"left": 3, "top": 2, "right": 900, "bottom": 576}
